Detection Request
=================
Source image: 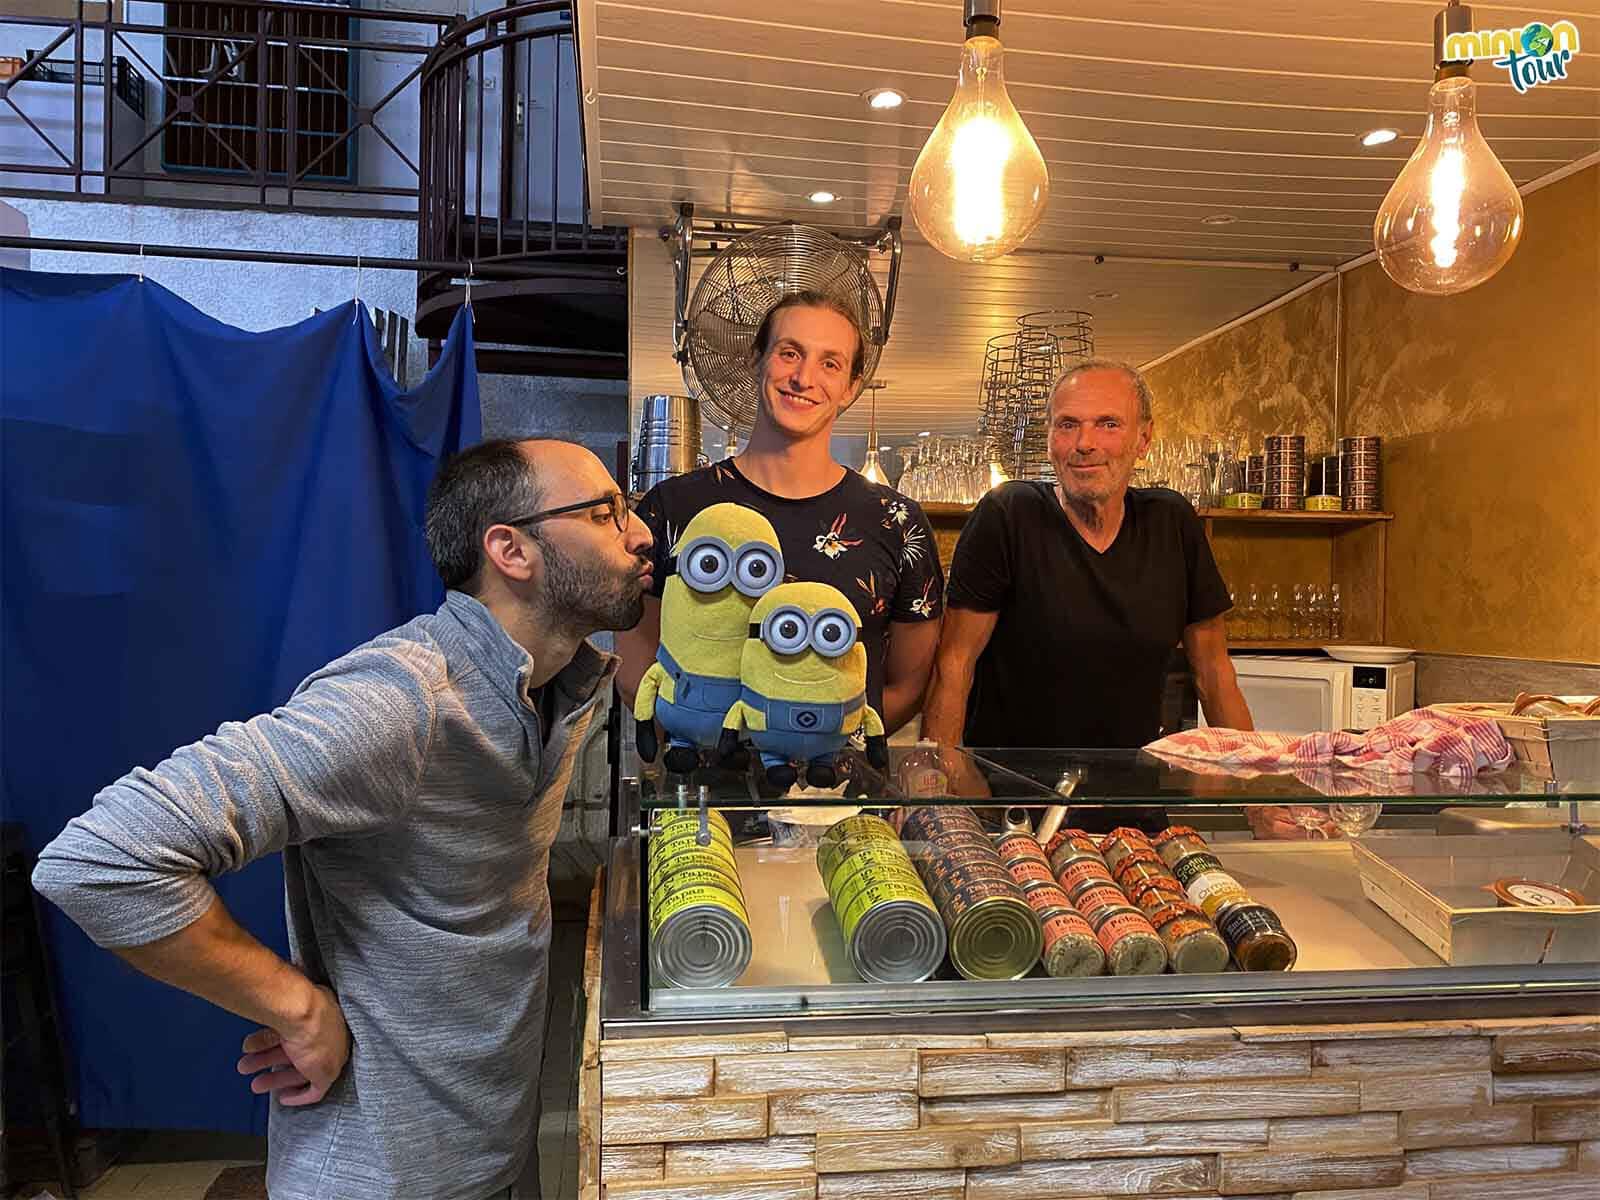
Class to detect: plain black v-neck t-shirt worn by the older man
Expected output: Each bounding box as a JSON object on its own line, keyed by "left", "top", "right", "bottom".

{"left": 949, "top": 482, "right": 1230, "bottom": 747}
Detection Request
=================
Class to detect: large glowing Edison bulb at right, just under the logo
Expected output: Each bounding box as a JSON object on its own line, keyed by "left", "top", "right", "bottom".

{"left": 1373, "top": 75, "right": 1522, "bottom": 296}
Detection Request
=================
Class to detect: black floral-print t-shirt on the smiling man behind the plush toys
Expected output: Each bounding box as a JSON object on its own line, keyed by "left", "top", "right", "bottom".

{"left": 638, "top": 458, "right": 944, "bottom": 712}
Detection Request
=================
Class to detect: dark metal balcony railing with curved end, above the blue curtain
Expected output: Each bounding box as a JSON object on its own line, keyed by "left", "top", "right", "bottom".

{"left": 0, "top": 0, "right": 614, "bottom": 224}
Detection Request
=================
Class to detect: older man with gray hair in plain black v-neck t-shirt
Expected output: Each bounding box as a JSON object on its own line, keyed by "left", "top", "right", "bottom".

{"left": 923, "top": 358, "right": 1251, "bottom": 800}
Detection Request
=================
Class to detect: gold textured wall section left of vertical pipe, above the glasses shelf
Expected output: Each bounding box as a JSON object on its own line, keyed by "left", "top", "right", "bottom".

{"left": 1146, "top": 280, "right": 1336, "bottom": 454}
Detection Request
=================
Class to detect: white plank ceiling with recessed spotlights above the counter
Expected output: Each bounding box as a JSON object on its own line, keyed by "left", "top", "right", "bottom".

{"left": 579, "top": 0, "right": 1600, "bottom": 438}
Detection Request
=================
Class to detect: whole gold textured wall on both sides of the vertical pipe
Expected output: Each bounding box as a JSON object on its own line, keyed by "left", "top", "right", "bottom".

{"left": 1149, "top": 166, "right": 1600, "bottom": 662}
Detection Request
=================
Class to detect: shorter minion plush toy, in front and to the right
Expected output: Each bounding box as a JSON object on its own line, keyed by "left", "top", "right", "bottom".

{"left": 720, "top": 584, "right": 890, "bottom": 787}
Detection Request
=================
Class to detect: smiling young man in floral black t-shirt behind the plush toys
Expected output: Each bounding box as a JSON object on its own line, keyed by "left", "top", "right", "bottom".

{"left": 616, "top": 293, "right": 944, "bottom": 733}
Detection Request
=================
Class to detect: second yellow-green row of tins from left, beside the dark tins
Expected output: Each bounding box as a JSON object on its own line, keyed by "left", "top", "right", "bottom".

{"left": 816, "top": 813, "right": 944, "bottom": 984}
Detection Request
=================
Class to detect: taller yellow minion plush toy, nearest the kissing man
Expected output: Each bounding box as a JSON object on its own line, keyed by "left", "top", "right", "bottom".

{"left": 634, "top": 504, "right": 784, "bottom": 773}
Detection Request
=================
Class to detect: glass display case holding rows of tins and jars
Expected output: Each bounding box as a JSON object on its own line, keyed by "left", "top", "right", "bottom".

{"left": 600, "top": 746, "right": 1600, "bottom": 1038}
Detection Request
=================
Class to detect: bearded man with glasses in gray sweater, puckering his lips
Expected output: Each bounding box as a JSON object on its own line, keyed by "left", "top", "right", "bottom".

{"left": 34, "top": 440, "right": 651, "bottom": 1200}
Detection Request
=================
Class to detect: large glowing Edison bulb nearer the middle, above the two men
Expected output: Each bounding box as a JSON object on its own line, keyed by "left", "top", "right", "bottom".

{"left": 910, "top": 37, "right": 1050, "bottom": 262}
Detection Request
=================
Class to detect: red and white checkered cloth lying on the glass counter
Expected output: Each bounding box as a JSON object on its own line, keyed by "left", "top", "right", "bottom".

{"left": 1144, "top": 707, "right": 1512, "bottom": 776}
